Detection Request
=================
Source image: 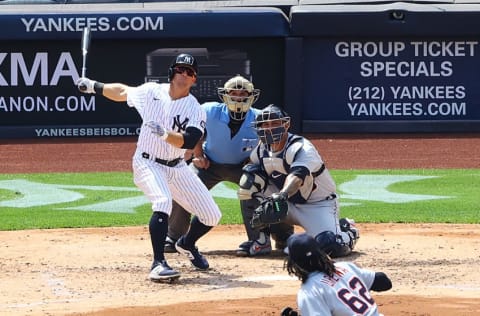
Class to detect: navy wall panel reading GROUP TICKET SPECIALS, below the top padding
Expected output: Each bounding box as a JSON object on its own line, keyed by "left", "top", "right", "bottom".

{"left": 304, "top": 38, "right": 480, "bottom": 121}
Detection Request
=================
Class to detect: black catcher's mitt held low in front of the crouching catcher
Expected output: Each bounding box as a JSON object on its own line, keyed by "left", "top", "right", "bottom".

{"left": 250, "top": 193, "right": 288, "bottom": 229}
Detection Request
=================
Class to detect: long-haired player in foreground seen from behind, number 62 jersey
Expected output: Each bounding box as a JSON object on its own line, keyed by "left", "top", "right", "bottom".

{"left": 282, "top": 234, "right": 392, "bottom": 316}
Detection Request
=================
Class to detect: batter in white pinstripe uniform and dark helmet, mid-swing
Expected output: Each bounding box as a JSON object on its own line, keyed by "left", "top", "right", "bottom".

{"left": 77, "top": 54, "right": 221, "bottom": 281}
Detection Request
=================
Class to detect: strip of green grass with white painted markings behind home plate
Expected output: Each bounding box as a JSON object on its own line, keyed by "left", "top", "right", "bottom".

{"left": 0, "top": 169, "right": 480, "bottom": 230}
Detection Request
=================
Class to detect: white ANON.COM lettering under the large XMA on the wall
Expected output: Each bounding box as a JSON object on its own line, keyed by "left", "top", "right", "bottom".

{"left": 0, "top": 96, "right": 95, "bottom": 112}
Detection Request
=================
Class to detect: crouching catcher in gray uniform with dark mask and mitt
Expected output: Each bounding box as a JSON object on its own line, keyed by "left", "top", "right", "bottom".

{"left": 238, "top": 105, "right": 359, "bottom": 257}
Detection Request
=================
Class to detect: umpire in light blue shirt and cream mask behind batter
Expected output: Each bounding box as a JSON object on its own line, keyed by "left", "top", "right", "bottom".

{"left": 165, "top": 75, "right": 293, "bottom": 256}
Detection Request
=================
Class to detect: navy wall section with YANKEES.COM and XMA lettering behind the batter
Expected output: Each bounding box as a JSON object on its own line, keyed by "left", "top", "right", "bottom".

{"left": 0, "top": 9, "right": 288, "bottom": 138}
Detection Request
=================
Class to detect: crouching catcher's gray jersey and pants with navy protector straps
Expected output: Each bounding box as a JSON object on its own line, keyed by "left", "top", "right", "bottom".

{"left": 250, "top": 134, "right": 344, "bottom": 232}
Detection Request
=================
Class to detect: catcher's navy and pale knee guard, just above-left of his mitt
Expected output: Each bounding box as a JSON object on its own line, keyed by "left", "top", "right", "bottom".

{"left": 237, "top": 164, "right": 268, "bottom": 200}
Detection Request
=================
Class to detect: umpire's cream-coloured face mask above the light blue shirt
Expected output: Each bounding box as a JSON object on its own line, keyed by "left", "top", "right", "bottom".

{"left": 217, "top": 75, "right": 260, "bottom": 121}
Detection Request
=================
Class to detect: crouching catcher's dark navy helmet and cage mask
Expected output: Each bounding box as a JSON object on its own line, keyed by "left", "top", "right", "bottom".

{"left": 253, "top": 104, "right": 290, "bottom": 145}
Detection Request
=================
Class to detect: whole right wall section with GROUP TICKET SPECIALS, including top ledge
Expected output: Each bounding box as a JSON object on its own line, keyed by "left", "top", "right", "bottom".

{"left": 286, "top": 1, "right": 480, "bottom": 132}
